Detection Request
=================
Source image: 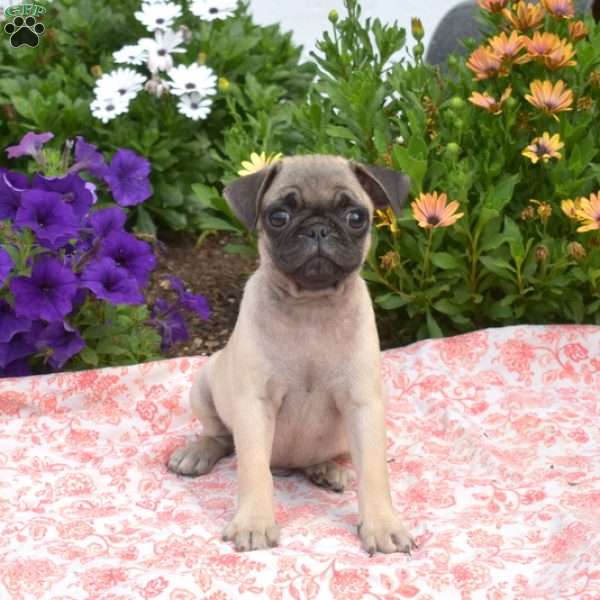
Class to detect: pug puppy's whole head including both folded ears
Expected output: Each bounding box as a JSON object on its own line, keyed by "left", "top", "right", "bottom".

{"left": 225, "top": 155, "right": 408, "bottom": 290}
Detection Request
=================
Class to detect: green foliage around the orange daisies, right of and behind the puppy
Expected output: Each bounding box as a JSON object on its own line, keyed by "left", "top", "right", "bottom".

{"left": 207, "top": 0, "right": 600, "bottom": 342}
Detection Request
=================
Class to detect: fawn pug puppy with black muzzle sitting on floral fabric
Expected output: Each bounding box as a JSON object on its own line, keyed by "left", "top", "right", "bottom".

{"left": 168, "top": 155, "right": 415, "bottom": 555}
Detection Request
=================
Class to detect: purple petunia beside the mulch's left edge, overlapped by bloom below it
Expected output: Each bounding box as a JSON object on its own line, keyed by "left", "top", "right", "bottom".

{"left": 98, "top": 231, "right": 156, "bottom": 287}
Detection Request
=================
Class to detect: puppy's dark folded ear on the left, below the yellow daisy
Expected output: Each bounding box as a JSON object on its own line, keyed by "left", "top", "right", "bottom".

{"left": 223, "top": 161, "right": 281, "bottom": 230}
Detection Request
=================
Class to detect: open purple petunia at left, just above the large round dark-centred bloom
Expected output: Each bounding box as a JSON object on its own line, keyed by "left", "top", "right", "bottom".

{"left": 15, "top": 190, "right": 79, "bottom": 250}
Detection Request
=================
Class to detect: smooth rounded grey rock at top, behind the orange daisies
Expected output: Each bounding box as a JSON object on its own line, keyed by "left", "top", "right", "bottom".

{"left": 425, "top": 0, "right": 600, "bottom": 66}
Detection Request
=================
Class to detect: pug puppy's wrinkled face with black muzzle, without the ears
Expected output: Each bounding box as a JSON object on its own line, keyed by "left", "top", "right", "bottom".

{"left": 258, "top": 157, "right": 373, "bottom": 290}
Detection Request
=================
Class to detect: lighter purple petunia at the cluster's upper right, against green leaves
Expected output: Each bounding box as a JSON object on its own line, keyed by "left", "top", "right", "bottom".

{"left": 104, "top": 148, "right": 152, "bottom": 206}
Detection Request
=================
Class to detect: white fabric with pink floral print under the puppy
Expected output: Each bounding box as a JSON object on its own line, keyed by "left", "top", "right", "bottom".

{"left": 0, "top": 326, "right": 600, "bottom": 600}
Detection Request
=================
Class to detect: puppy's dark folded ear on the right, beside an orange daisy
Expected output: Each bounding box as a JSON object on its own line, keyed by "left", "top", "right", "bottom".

{"left": 351, "top": 162, "right": 410, "bottom": 215}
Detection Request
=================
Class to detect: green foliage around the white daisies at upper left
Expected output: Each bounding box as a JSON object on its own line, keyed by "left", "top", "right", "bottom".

{"left": 0, "top": 0, "right": 314, "bottom": 234}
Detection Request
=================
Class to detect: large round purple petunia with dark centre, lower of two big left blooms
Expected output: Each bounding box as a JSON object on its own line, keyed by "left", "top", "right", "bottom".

{"left": 10, "top": 256, "right": 77, "bottom": 321}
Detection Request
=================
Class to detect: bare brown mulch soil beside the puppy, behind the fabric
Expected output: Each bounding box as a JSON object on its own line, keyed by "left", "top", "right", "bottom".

{"left": 147, "top": 234, "right": 404, "bottom": 357}
